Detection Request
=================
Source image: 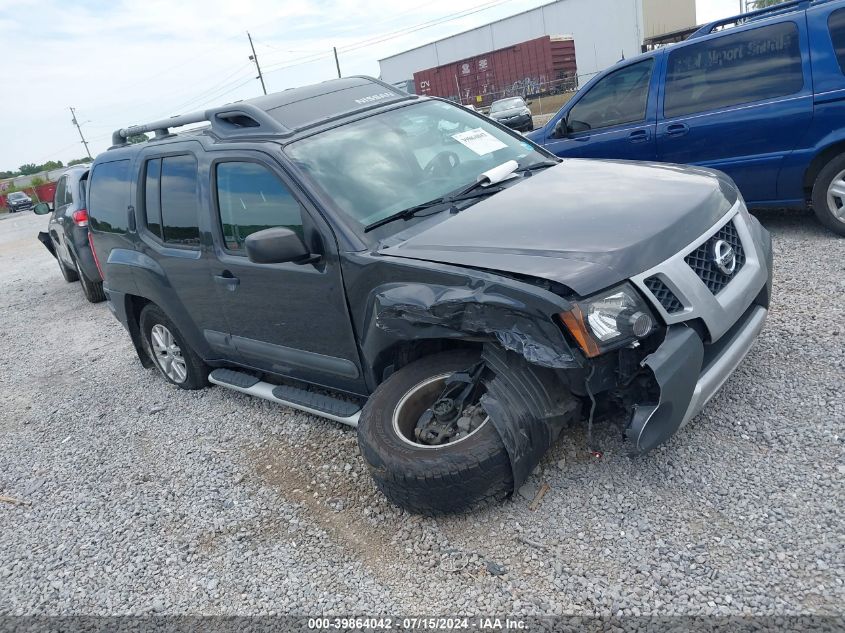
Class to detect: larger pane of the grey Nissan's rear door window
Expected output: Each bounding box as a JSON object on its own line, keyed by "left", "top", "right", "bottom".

{"left": 161, "top": 156, "right": 200, "bottom": 246}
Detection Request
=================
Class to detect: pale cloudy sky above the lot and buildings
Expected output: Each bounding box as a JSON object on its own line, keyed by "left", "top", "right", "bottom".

{"left": 0, "top": 0, "right": 740, "bottom": 171}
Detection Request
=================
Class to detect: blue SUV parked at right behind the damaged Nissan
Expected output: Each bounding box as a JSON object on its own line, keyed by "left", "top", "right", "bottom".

{"left": 528, "top": 0, "right": 845, "bottom": 235}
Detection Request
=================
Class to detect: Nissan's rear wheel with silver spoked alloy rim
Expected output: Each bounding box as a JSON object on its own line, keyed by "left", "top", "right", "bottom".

{"left": 140, "top": 303, "right": 209, "bottom": 389}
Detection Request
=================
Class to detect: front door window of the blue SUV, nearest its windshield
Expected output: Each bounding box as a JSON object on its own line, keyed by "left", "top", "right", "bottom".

{"left": 567, "top": 59, "right": 654, "bottom": 132}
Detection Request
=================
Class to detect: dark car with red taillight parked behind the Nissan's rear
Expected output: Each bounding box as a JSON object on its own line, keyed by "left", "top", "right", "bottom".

{"left": 35, "top": 167, "right": 106, "bottom": 303}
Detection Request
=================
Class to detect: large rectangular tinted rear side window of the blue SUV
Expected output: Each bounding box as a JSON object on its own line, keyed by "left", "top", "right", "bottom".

{"left": 664, "top": 21, "right": 804, "bottom": 118}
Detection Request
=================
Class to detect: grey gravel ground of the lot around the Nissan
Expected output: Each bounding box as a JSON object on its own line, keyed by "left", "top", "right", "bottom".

{"left": 0, "top": 213, "right": 845, "bottom": 616}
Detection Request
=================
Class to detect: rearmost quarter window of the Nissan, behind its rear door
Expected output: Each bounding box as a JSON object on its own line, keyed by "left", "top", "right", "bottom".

{"left": 88, "top": 160, "right": 130, "bottom": 233}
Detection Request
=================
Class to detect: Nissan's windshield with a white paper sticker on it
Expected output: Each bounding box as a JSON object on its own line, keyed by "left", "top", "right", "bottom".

{"left": 285, "top": 101, "right": 548, "bottom": 232}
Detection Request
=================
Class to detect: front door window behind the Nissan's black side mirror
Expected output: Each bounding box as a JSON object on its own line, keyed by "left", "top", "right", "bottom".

{"left": 217, "top": 162, "right": 302, "bottom": 251}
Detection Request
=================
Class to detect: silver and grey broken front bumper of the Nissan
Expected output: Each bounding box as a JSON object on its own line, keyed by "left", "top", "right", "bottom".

{"left": 626, "top": 202, "right": 772, "bottom": 454}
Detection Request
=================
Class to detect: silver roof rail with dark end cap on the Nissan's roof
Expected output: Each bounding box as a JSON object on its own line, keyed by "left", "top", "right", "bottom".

{"left": 110, "top": 103, "right": 291, "bottom": 149}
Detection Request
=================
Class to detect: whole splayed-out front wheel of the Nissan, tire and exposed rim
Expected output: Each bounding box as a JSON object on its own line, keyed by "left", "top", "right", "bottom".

{"left": 358, "top": 350, "right": 513, "bottom": 514}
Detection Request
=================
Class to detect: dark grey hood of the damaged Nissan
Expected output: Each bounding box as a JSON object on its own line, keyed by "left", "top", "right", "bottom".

{"left": 381, "top": 159, "right": 738, "bottom": 295}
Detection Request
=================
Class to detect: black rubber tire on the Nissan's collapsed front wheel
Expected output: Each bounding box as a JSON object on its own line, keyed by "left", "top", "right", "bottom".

{"left": 358, "top": 350, "right": 513, "bottom": 514}
